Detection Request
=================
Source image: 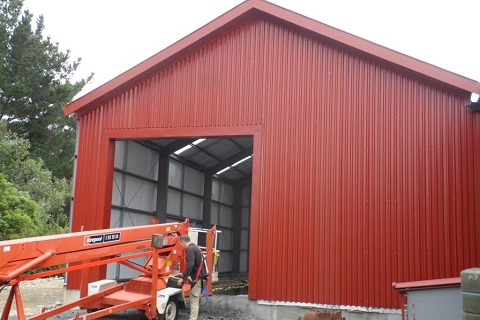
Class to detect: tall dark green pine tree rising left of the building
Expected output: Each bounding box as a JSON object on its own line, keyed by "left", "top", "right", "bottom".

{"left": 0, "top": 0, "right": 93, "bottom": 178}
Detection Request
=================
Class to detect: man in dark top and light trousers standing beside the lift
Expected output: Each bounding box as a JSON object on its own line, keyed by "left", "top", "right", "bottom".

{"left": 178, "top": 235, "right": 207, "bottom": 320}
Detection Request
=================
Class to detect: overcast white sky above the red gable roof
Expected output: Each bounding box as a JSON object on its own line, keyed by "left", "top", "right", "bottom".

{"left": 24, "top": 0, "right": 480, "bottom": 97}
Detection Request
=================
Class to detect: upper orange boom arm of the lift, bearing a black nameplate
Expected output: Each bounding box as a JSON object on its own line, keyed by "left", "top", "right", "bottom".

{"left": 0, "top": 220, "right": 188, "bottom": 285}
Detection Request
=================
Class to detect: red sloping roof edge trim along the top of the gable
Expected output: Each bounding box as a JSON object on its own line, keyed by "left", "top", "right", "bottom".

{"left": 64, "top": 0, "right": 480, "bottom": 115}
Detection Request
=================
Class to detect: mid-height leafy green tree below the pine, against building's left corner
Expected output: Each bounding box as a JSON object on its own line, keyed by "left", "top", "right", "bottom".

{"left": 0, "top": 120, "right": 71, "bottom": 235}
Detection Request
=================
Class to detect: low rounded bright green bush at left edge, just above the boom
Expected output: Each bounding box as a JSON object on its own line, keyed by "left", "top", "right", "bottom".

{"left": 0, "top": 173, "right": 40, "bottom": 241}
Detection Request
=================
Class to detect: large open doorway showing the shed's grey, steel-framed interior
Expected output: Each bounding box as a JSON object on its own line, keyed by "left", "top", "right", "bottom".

{"left": 107, "top": 136, "right": 254, "bottom": 290}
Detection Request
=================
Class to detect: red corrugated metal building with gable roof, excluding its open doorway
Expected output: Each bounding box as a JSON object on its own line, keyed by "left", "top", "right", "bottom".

{"left": 64, "top": 0, "right": 480, "bottom": 308}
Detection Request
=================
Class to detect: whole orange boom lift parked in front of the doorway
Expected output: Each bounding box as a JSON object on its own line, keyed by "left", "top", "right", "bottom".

{"left": 0, "top": 219, "right": 216, "bottom": 320}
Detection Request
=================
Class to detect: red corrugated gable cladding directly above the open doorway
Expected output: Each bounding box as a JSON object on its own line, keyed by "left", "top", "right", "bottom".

{"left": 100, "top": 28, "right": 263, "bottom": 129}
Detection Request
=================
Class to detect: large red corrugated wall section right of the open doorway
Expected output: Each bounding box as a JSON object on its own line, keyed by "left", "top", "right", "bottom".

{"left": 253, "top": 19, "right": 480, "bottom": 307}
